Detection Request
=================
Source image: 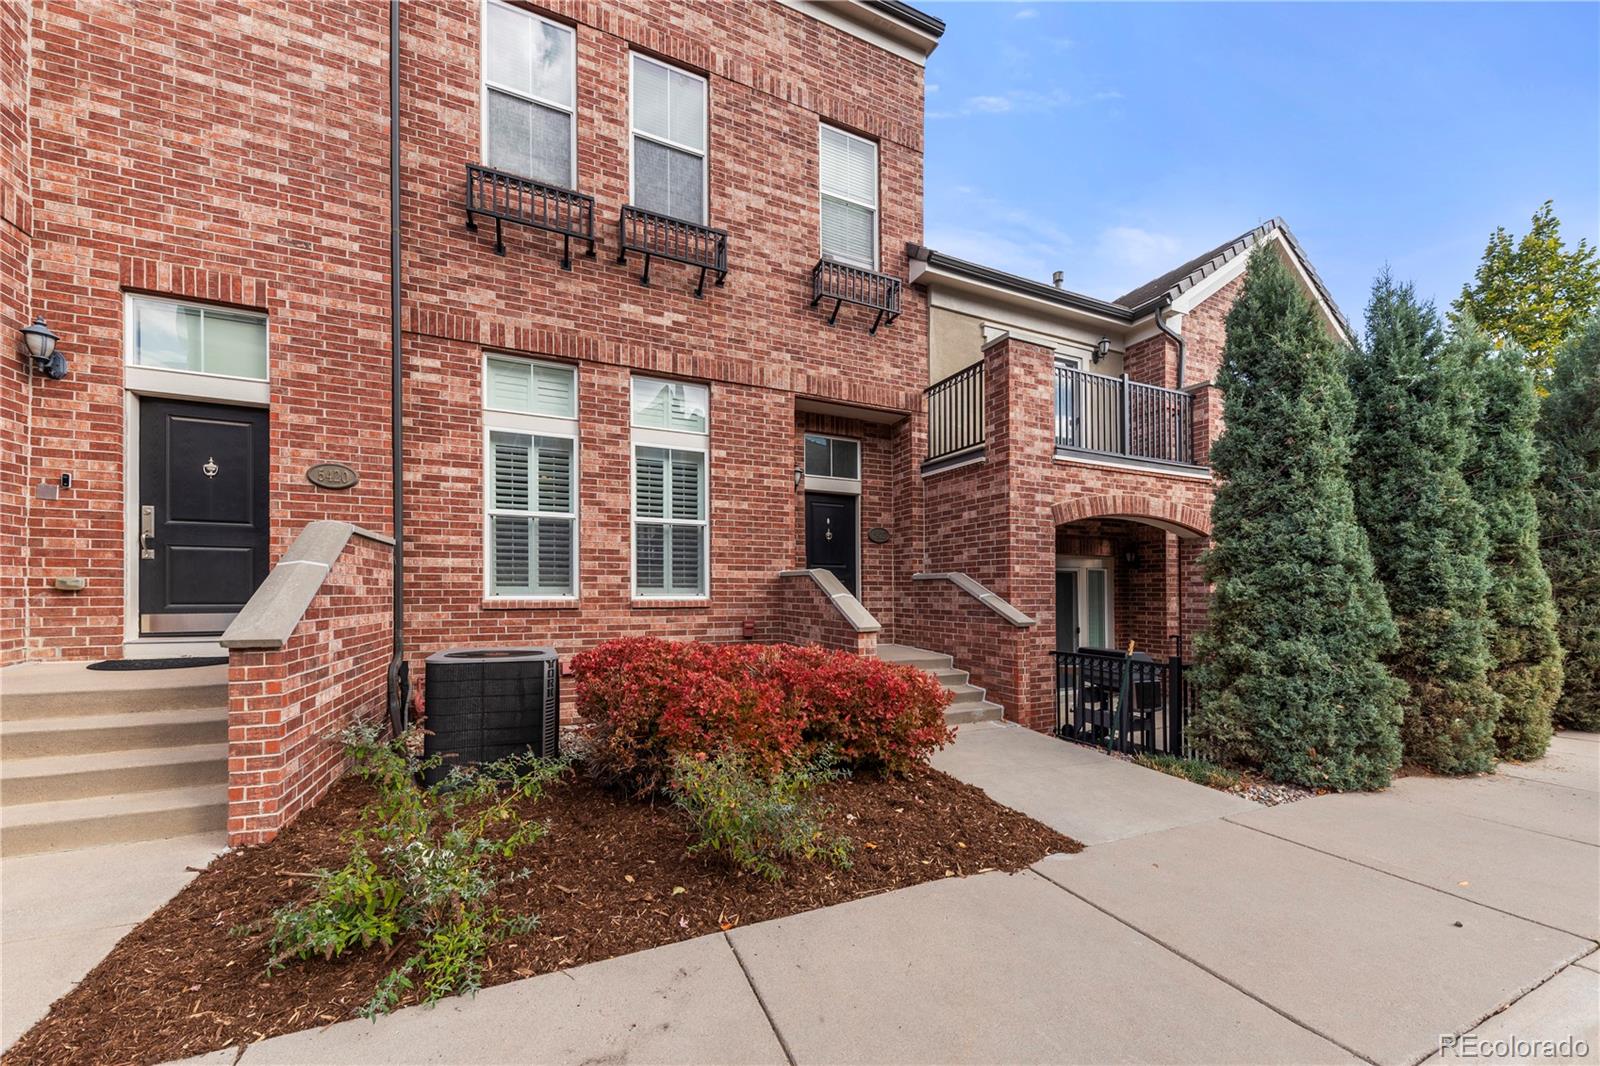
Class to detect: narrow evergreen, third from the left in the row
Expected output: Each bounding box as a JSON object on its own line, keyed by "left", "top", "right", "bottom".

{"left": 1451, "top": 320, "right": 1562, "bottom": 760}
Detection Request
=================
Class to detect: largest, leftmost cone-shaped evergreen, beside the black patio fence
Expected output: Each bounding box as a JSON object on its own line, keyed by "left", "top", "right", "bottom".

{"left": 1190, "top": 248, "right": 1400, "bottom": 789}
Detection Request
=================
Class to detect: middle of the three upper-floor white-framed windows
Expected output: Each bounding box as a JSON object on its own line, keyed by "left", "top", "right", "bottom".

{"left": 629, "top": 53, "right": 709, "bottom": 226}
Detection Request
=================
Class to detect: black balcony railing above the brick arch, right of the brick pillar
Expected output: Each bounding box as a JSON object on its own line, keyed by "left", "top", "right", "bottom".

{"left": 1056, "top": 363, "right": 1194, "bottom": 464}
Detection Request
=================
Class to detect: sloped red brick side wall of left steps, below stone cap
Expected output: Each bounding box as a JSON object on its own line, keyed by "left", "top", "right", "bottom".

{"left": 227, "top": 535, "right": 394, "bottom": 845}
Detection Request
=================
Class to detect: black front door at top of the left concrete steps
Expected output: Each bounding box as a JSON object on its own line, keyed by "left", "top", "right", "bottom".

{"left": 136, "top": 400, "right": 269, "bottom": 635}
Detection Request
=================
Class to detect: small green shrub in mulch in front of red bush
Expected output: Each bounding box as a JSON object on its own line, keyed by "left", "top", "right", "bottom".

{"left": 670, "top": 751, "right": 850, "bottom": 880}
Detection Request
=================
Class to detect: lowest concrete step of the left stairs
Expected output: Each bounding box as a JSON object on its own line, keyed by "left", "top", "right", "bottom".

{"left": 0, "top": 784, "right": 227, "bottom": 857}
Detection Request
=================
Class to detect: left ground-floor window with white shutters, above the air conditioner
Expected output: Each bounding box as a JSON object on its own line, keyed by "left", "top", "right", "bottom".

{"left": 483, "top": 355, "right": 578, "bottom": 599}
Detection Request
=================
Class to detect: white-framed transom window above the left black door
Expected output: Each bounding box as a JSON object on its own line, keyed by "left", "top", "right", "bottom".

{"left": 123, "top": 296, "right": 267, "bottom": 381}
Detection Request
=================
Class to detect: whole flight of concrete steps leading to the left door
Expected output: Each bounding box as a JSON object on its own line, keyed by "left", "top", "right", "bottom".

{"left": 0, "top": 663, "right": 227, "bottom": 856}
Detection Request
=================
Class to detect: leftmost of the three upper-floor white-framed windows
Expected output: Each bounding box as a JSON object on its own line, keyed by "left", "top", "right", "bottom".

{"left": 482, "top": 0, "right": 578, "bottom": 189}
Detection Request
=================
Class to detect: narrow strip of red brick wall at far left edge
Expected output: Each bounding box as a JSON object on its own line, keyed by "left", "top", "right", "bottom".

{"left": 0, "top": 3, "right": 34, "bottom": 666}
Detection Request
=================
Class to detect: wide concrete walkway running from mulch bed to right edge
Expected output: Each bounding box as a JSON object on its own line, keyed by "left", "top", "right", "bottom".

{"left": 168, "top": 725, "right": 1600, "bottom": 1066}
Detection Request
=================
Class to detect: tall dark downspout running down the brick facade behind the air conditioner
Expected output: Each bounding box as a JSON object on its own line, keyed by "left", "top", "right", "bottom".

{"left": 389, "top": 0, "right": 411, "bottom": 733}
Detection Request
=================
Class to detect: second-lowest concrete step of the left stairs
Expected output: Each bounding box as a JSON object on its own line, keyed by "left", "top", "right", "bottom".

{"left": 0, "top": 744, "right": 227, "bottom": 807}
